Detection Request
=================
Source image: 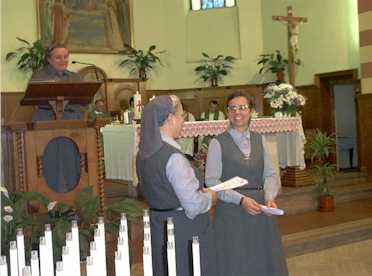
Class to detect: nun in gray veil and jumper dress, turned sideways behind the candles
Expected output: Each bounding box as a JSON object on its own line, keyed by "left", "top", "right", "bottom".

{"left": 136, "top": 95, "right": 216, "bottom": 276}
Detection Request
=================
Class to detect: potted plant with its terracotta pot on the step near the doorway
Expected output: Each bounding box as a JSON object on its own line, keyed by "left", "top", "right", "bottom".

{"left": 310, "top": 129, "right": 335, "bottom": 212}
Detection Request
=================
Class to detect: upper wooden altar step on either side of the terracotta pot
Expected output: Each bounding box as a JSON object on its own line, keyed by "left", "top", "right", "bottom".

{"left": 276, "top": 172, "right": 372, "bottom": 214}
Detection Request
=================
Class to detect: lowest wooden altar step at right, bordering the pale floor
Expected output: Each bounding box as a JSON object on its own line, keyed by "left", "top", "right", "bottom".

{"left": 278, "top": 199, "right": 372, "bottom": 257}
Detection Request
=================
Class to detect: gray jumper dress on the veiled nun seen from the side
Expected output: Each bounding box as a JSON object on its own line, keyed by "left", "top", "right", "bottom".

{"left": 137, "top": 143, "right": 216, "bottom": 276}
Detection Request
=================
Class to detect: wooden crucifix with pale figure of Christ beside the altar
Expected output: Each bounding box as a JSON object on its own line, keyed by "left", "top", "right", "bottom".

{"left": 273, "top": 6, "right": 307, "bottom": 86}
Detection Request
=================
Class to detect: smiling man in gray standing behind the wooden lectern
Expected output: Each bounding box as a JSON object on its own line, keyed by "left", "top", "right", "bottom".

{"left": 30, "top": 44, "right": 83, "bottom": 121}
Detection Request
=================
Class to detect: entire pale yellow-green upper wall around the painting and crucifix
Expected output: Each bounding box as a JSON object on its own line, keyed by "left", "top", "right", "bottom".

{"left": 1, "top": 0, "right": 359, "bottom": 92}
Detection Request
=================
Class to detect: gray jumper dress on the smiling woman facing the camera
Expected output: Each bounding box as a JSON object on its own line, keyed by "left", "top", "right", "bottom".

{"left": 215, "top": 132, "right": 288, "bottom": 276}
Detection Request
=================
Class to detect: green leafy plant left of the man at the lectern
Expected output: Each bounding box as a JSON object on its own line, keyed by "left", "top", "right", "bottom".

{"left": 5, "top": 37, "right": 46, "bottom": 72}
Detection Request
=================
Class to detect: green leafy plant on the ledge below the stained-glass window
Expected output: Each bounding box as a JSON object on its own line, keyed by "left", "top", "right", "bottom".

{"left": 194, "top": 52, "right": 236, "bottom": 86}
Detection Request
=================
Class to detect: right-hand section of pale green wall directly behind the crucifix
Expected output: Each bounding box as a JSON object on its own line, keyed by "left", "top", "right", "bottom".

{"left": 262, "top": 0, "right": 360, "bottom": 85}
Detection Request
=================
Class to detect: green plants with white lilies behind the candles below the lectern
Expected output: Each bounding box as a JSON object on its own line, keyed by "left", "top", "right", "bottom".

{"left": 1, "top": 186, "right": 142, "bottom": 259}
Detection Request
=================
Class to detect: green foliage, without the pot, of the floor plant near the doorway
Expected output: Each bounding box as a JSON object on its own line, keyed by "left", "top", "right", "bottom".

{"left": 310, "top": 129, "right": 335, "bottom": 196}
